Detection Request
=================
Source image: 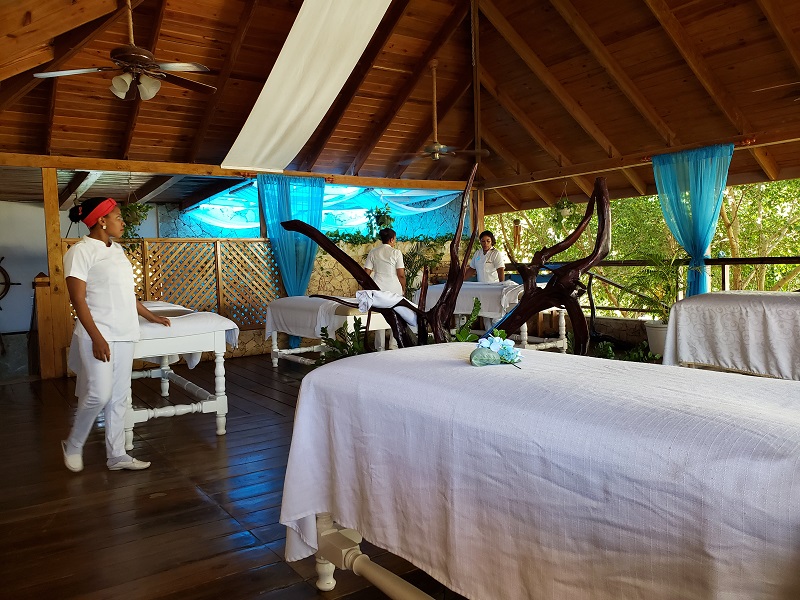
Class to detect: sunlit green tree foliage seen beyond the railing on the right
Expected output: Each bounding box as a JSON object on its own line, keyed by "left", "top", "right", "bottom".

{"left": 486, "top": 180, "right": 800, "bottom": 317}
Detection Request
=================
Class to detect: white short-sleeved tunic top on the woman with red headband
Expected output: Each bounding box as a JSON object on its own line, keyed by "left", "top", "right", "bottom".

{"left": 64, "top": 236, "right": 139, "bottom": 342}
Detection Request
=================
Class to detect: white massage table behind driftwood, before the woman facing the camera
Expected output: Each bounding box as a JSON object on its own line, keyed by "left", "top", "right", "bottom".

{"left": 414, "top": 280, "right": 567, "bottom": 352}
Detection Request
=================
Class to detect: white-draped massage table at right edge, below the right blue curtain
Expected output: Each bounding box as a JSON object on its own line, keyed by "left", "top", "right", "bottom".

{"left": 663, "top": 291, "right": 800, "bottom": 380}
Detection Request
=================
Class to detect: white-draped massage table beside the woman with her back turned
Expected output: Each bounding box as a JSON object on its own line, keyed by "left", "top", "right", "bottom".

{"left": 266, "top": 296, "right": 389, "bottom": 367}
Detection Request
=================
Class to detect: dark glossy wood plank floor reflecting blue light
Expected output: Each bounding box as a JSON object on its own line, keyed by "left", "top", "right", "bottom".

{"left": 0, "top": 357, "right": 460, "bottom": 600}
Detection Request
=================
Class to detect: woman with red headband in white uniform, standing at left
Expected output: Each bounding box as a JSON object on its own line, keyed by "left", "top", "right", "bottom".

{"left": 61, "top": 198, "right": 170, "bottom": 472}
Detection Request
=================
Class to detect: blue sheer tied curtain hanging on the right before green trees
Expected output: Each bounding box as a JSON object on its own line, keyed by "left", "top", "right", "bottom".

{"left": 653, "top": 144, "right": 733, "bottom": 296}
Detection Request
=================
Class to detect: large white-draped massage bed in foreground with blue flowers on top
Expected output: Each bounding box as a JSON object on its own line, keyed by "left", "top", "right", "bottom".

{"left": 280, "top": 343, "right": 800, "bottom": 600}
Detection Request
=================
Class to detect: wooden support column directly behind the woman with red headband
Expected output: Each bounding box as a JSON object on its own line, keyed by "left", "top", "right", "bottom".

{"left": 39, "top": 168, "right": 72, "bottom": 379}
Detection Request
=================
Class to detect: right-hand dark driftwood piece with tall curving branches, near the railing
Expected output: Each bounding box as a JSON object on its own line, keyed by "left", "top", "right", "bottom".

{"left": 487, "top": 177, "right": 611, "bottom": 354}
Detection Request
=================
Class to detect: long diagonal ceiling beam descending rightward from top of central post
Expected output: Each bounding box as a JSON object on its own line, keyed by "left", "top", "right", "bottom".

{"left": 479, "top": 0, "right": 647, "bottom": 194}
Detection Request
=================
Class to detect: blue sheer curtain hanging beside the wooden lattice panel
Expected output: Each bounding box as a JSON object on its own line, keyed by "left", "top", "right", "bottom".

{"left": 258, "top": 175, "right": 325, "bottom": 348}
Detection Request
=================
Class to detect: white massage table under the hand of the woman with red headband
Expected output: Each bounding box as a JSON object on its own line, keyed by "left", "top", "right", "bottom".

{"left": 125, "top": 302, "right": 239, "bottom": 450}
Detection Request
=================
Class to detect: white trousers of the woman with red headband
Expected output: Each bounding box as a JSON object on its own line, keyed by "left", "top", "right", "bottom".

{"left": 67, "top": 336, "right": 135, "bottom": 459}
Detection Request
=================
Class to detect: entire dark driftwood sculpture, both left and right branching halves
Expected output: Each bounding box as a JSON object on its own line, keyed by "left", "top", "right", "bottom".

{"left": 281, "top": 170, "right": 611, "bottom": 354}
